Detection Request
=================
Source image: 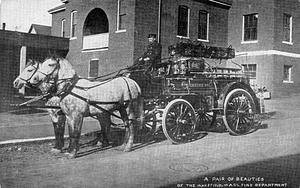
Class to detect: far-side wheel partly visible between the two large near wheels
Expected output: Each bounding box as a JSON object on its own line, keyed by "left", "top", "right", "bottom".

{"left": 194, "top": 95, "right": 217, "bottom": 130}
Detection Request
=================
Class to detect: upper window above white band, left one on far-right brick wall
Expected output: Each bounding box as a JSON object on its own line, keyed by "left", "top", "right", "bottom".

{"left": 243, "top": 14, "right": 258, "bottom": 41}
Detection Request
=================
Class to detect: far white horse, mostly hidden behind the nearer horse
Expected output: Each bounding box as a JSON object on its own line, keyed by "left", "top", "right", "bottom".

{"left": 13, "top": 60, "right": 66, "bottom": 153}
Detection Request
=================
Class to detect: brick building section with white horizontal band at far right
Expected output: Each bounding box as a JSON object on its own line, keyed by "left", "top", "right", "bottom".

{"left": 228, "top": 0, "right": 300, "bottom": 97}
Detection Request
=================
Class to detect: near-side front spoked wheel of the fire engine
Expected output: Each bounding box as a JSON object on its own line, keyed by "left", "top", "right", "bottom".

{"left": 162, "top": 99, "right": 196, "bottom": 144}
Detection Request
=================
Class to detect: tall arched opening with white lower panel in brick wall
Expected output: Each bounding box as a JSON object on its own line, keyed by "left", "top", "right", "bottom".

{"left": 83, "top": 8, "right": 109, "bottom": 50}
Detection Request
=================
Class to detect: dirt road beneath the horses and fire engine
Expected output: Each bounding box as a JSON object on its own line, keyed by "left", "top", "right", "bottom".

{"left": 0, "top": 96, "right": 300, "bottom": 188}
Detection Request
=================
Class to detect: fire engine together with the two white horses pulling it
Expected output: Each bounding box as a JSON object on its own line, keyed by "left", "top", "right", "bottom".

{"left": 14, "top": 42, "right": 260, "bottom": 158}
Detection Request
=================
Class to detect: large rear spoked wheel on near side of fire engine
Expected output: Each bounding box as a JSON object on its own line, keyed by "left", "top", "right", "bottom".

{"left": 223, "top": 89, "right": 257, "bottom": 135}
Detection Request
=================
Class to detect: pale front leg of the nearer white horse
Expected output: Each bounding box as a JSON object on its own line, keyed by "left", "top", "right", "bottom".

{"left": 66, "top": 114, "right": 83, "bottom": 159}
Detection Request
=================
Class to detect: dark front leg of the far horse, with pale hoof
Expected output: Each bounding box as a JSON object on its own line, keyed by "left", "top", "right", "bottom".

{"left": 49, "top": 110, "right": 66, "bottom": 153}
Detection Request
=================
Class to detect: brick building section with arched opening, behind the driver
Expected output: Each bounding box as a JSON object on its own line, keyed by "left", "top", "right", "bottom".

{"left": 49, "top": 0, "right": 231, "bottom": 77}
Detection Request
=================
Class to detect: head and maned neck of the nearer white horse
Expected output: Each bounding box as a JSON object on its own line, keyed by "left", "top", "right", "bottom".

{"left": 29, "top": 57, "right": 76, "bottom": 92}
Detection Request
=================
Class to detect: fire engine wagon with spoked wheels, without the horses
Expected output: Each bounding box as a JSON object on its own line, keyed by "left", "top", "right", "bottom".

{"left": 130, "top": 42, "right": 260, "bottom": 144}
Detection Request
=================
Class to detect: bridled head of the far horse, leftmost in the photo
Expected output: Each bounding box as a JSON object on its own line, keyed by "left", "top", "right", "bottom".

{"left": 13, "top": 59, "right": 41, "bottom": 89}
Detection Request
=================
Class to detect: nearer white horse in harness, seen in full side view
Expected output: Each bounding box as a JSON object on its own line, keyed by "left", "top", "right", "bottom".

{"left": 29, "top": 58, "right": 142, "bottom": 158}
